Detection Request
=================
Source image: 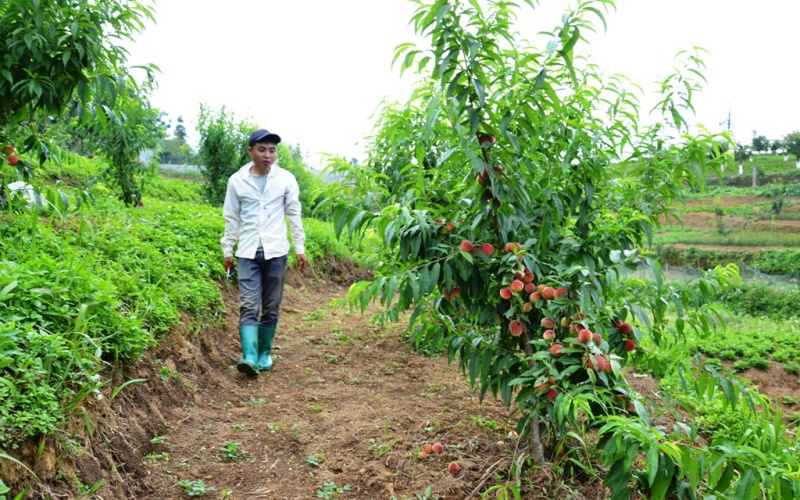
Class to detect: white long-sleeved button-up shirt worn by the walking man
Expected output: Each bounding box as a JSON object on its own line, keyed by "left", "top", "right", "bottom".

{"left": 220, "top": 162, "right": 306, "bottom": 259}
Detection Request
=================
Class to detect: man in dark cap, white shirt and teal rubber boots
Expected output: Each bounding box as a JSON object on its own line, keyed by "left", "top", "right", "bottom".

{"left": 220, "top": 129, "right": 308, "bottom": 377}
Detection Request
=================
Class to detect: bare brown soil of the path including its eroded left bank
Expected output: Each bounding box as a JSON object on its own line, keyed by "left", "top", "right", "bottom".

{"left": 9, "top": 265, "right": 607, "bottom": 500}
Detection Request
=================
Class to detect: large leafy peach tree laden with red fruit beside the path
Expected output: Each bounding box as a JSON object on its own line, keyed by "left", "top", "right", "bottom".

{"left": 320, "top": 0, "right": 735, "bottom": 488}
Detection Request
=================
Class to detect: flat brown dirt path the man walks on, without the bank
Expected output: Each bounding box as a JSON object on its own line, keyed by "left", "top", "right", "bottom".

{"left": 106, "top": 274, "right": 600, "bottom": 499}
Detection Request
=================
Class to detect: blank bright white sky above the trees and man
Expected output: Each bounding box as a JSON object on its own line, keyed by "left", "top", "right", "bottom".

{"left": 128, "top": 0, "right": 800, "bottom": 169}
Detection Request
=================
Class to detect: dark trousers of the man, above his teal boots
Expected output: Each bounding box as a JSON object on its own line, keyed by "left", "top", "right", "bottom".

{"left": 238, "top": 250, "right": 289, "bottom": 326}
